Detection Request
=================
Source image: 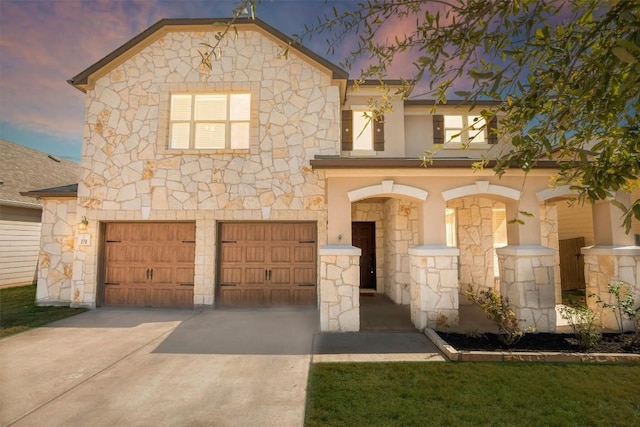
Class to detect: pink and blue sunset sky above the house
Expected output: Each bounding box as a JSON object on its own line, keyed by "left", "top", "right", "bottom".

{"left": 0, "top": 0, "right": 420, "bottom": 161}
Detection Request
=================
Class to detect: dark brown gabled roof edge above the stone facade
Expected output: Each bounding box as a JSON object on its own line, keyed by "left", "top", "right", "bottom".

{"left": 67, "top": 18, "right": 349, "bottom": 92}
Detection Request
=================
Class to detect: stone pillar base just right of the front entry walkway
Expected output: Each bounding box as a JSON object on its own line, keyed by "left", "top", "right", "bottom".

{"left": 409, "top": 246, "right": 460, "bottom": 330}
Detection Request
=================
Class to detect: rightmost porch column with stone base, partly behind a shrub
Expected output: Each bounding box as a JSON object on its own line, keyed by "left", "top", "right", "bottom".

{"left": 582, "top": 192, "right": 640, "bottom": 330}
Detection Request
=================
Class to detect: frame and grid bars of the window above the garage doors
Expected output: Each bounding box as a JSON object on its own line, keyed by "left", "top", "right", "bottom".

{"left": 166, "top": 90, "right": 253, "bottom": 152}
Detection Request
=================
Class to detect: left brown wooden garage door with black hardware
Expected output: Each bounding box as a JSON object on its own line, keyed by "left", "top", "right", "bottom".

{"left": 104, "top": 223, "right": 196, "bottom": 307}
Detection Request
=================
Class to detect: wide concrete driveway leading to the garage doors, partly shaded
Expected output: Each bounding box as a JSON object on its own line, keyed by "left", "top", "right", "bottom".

{"left": 0, "top": 308, "right": 319, "bottom": 426}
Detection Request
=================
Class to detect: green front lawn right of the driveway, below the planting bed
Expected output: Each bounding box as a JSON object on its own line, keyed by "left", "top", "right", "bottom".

{"left": 305, "top": 362, "right": 640, "bottom": 427}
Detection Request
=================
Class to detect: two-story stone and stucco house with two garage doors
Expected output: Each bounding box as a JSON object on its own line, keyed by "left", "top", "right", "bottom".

{"left": 23, "top": 19, "right": 640, "bottom": 331}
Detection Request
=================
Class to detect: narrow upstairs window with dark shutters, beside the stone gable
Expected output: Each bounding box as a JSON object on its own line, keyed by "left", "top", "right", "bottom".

{"left": 342, "top": 107, "right": 384, "bottom": 153}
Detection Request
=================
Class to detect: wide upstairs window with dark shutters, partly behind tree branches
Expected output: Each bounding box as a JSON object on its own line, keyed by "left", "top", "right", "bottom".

{"left": 433, "top": 115, "right": 498, "bottom": 147}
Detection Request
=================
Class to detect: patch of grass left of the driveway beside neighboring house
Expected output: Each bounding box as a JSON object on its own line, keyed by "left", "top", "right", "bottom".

{"left": 0, "top": 285, "right": 87, "bottom": 338}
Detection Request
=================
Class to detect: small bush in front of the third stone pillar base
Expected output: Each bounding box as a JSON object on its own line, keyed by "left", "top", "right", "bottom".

{"left": 465, "top": 287, "right": 528, "bottom": 347}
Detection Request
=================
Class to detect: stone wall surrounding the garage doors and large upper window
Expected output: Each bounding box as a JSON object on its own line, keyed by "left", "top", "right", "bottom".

{"left": 40, "top": 27, "right": 341, "bottom": 306}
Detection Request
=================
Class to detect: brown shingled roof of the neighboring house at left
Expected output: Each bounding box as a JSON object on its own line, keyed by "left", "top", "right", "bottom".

{"left": 0, "top": 139, "right": 80, "bottom": 208}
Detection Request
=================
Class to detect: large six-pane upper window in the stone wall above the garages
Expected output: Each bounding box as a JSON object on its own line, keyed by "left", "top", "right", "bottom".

{"left": 169, "top": 93, "right": 251, "bottom": 150}
